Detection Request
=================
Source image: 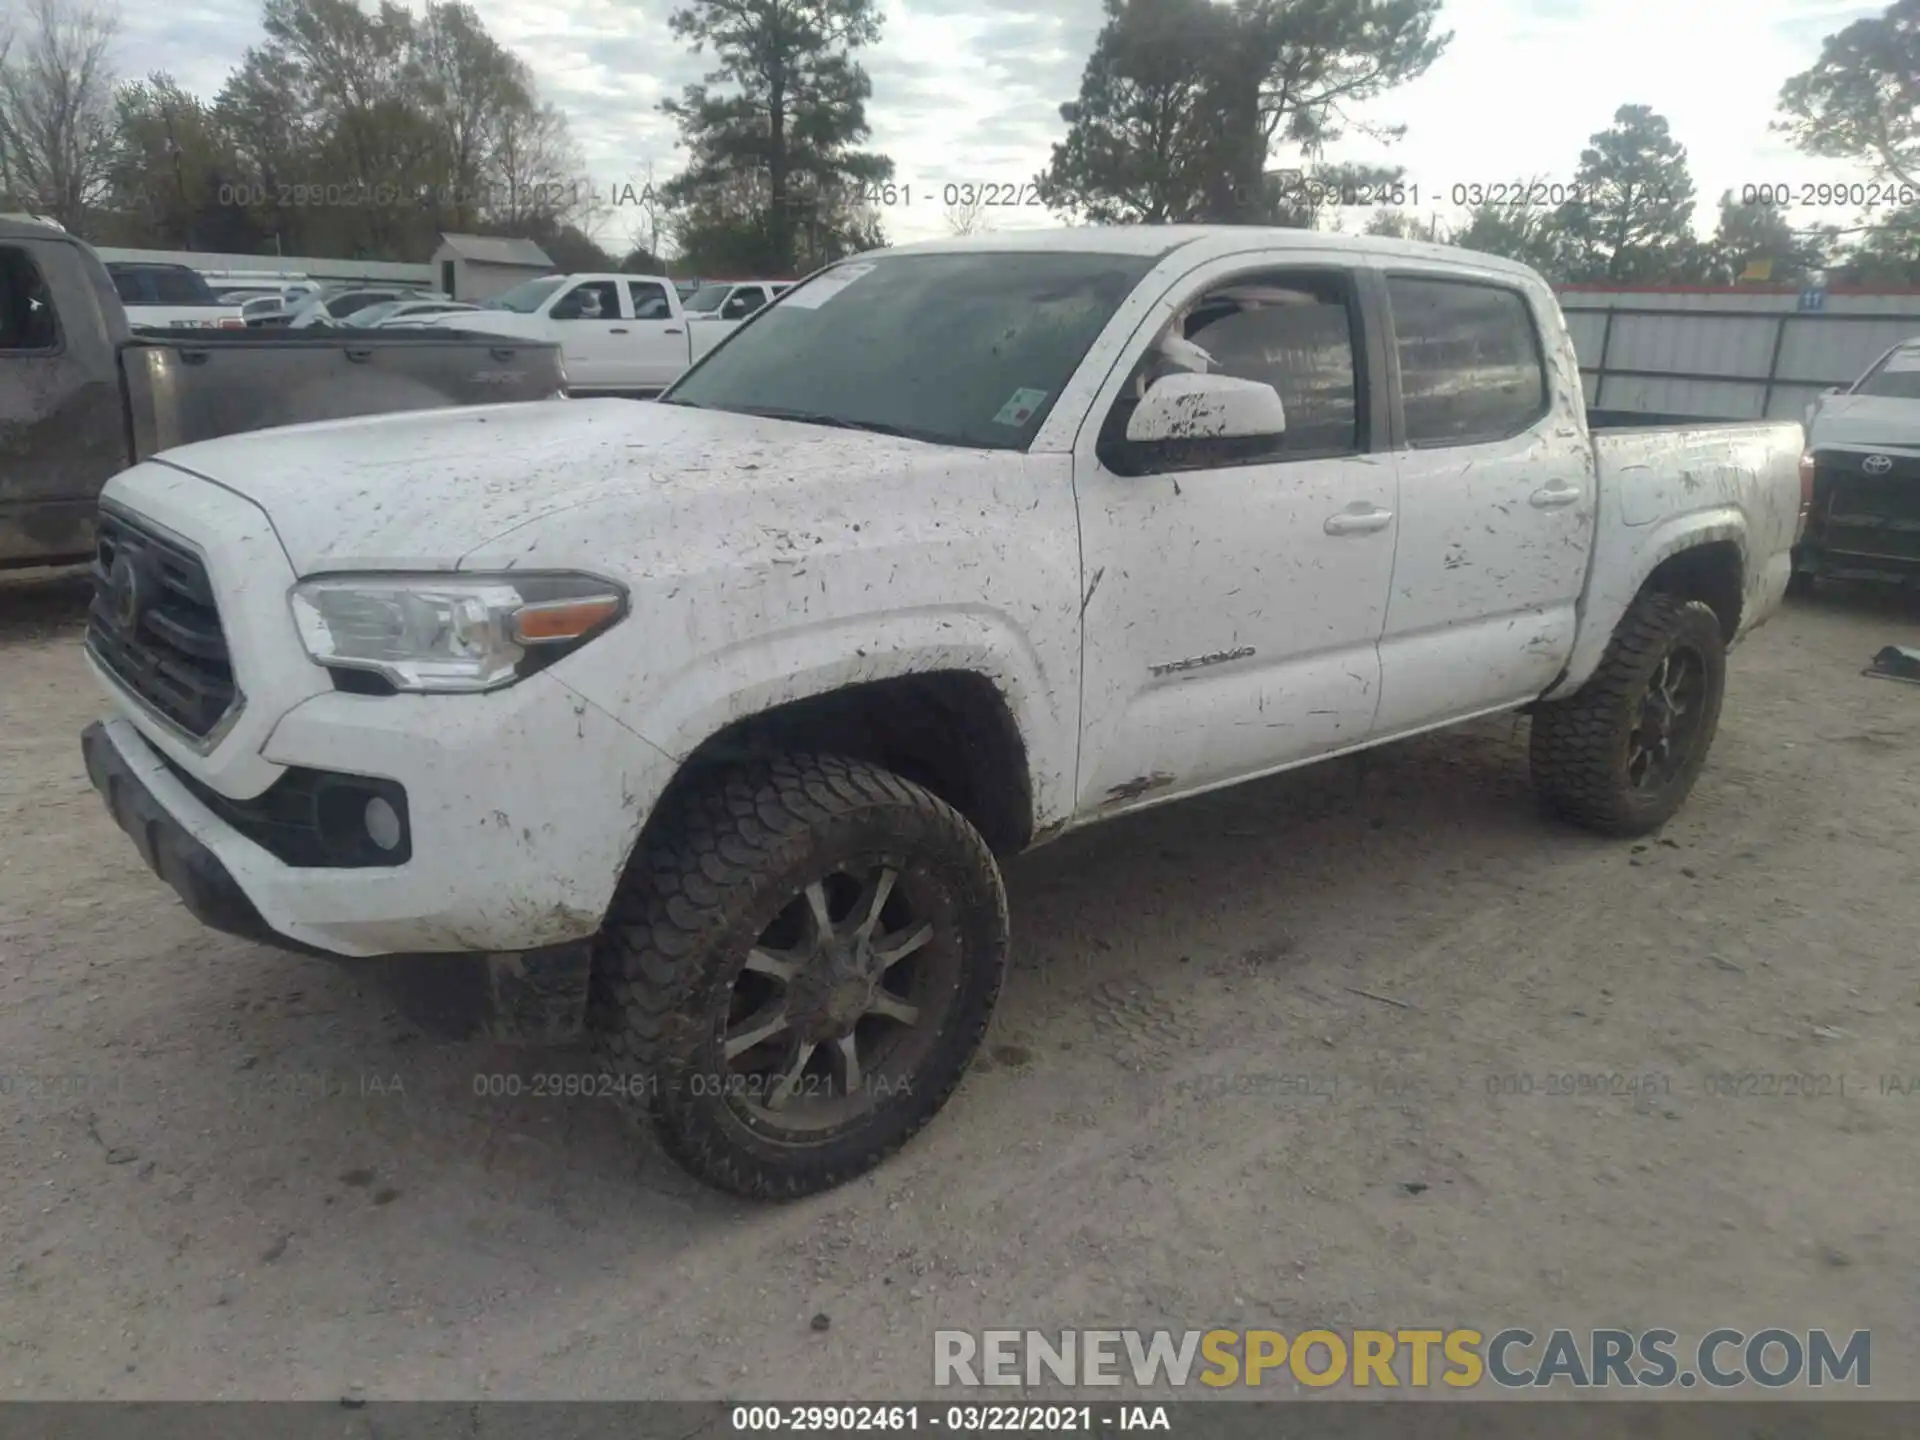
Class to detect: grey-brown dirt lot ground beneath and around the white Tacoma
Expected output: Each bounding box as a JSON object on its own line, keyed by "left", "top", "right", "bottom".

{"left": 0, "top": 568, "right": 1920, "bottom": 1400}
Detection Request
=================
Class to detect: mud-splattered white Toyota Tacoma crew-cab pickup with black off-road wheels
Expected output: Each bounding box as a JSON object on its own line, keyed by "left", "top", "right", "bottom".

{"left": 84, "top": 227, "right": 1803, "bottom": 1196}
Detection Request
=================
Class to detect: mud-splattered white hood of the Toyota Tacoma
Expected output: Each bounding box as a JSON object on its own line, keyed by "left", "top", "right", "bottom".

{"left": 131, "top": 399, "right": 952, "bottom": 574}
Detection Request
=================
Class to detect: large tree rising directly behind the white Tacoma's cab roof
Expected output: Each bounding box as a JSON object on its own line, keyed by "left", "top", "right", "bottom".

{"left": 1039, "top": 0, "right": 1452, "bottom": 223}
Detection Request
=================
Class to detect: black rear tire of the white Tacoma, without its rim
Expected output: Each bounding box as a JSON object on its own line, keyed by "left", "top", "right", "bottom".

{"left": 1528, "top": 591, "right": 1726, "bottom": 837}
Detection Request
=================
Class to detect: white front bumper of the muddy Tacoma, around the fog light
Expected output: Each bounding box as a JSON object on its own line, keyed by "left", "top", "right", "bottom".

{"left": 83, "top": 666, "right": 664, "bottom": 958}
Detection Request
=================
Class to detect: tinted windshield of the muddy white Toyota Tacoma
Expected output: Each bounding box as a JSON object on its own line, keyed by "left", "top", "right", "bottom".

{"left": 662, "top": 250, "right": 1158, "bottom": 449}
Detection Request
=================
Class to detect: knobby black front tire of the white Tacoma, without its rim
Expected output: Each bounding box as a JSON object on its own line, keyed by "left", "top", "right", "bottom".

{"left": 591, "top": 755, "right": 1008, "bottom": 1200}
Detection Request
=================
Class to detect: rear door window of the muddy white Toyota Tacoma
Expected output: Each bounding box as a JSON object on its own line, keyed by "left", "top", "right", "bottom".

{"left": 1386, "top": 275, "right": 1551, "bottom": 449}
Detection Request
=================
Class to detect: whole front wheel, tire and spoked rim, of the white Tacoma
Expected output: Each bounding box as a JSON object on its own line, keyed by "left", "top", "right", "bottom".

{"left": 595, "top": 756, "right": 1008, "bottom": 1198}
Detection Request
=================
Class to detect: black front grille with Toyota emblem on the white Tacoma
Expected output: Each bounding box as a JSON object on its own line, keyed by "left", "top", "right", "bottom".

{"left": 86, "top": 507, "right": 238, "bottom": 739}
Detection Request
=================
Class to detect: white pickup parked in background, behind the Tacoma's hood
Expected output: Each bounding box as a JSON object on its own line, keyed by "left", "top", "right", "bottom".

{"left": 434, "top": 275, "right": 753, "bottom": 396}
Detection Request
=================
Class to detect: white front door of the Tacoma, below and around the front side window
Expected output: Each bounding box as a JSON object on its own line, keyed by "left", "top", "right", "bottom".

{"left": 1073, "top": 255, "right": 1398, "bottom": 814}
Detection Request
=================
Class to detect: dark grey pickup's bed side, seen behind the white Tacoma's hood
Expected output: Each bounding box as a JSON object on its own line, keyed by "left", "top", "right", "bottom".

{"left": 121, "top": 330, "right": 564, "bottom": 459}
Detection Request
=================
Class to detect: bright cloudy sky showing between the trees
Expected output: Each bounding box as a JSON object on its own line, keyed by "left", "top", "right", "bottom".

{"left": 108, "top": 0, "right": 1882, "bottom": 246}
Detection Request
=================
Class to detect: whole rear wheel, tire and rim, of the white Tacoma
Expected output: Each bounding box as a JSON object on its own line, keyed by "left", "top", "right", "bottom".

{"left": 1528, "top": 593, "right": 1726, "bottom": 835}
